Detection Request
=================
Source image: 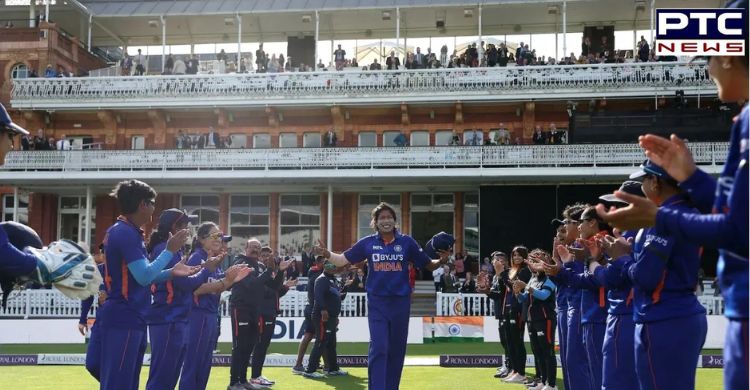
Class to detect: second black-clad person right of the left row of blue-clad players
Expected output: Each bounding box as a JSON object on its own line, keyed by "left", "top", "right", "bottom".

{"left": 250, "top": 246, "right": 289, "bottom": 386}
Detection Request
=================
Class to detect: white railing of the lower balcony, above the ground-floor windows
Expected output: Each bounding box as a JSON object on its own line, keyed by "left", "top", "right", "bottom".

{"left": 0, "top": 142, "right": 728, "bottom": 176}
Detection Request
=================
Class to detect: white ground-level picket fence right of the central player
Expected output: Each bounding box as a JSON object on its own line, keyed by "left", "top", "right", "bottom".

{"left": 435, "top": 293, "right": 724, "bottom": 316}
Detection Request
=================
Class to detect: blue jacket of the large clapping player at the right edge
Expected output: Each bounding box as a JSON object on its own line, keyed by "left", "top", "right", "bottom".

{"left": 655, "top": 105, "right": 750, "bottom": 319}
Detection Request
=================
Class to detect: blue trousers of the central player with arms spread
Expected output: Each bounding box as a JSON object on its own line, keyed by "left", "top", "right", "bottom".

{"left": 367, "top": 294, "right": 411, "bottom": 390}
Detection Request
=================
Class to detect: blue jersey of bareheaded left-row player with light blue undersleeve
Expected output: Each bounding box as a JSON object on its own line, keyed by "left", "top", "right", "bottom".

{"left": 104, "top": 217, "right": 151, "bottom": 328}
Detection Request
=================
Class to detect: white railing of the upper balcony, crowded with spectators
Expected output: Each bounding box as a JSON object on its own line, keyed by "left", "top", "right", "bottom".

{"left": 11, "top": 62, "right": 715, "bottom": 109}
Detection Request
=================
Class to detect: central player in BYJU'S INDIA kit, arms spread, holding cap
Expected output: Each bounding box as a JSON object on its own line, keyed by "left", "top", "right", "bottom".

{"left": 315, "top": 203, "right": 453, "bottom": 390}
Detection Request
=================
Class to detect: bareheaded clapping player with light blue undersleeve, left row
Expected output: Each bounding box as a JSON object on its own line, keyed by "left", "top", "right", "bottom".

{"left": 97, "top": 180, "right": 200, "bottom": 390}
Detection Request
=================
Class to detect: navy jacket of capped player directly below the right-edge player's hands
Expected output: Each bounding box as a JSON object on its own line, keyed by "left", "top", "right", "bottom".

{"left": 628, "top": 195, "right": 706, "bottom": 323}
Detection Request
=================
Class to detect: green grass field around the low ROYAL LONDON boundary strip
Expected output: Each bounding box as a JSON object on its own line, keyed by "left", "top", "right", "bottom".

{"left": 0, "top": 343, "right": 722, "bottom": 390}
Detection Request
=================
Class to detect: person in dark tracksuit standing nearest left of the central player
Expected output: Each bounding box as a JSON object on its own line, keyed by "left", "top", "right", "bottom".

{"left": 304, "top": 262, "right": 346, "bottom": 378}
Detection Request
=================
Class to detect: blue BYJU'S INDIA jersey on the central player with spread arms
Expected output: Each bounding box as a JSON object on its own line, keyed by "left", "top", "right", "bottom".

{"left": 344, "top": 231, "right": 432, "bottom": 296}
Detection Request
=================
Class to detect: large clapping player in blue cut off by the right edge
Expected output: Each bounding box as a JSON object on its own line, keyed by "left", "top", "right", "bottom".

{"left": 598, "top": 0, "right": 750, "bottom": 389}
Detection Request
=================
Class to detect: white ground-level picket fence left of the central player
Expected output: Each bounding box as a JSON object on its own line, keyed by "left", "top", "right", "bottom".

{"left": 0, "top": 290, "right": 367, "bottom": 319}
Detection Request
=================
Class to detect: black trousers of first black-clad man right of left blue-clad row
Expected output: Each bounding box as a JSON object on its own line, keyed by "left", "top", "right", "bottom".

{"left": 229, "top": 308, "right": 260, "bottom": 385}
